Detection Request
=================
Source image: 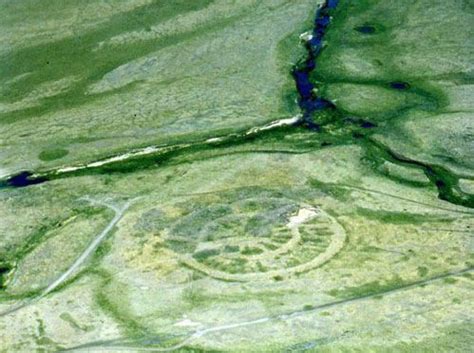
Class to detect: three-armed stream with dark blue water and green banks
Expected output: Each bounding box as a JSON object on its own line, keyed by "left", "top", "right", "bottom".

{"left": 0, "top": 0, "right": 474, "bottom": 212}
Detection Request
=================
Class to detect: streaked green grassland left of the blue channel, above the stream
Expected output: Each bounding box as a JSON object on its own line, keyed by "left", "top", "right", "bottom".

{"left": 0, "top": 0, "right": 315, "bottom": 175}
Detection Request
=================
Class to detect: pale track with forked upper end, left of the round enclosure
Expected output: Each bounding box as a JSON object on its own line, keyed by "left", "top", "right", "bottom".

{"left": 0, "top": 197, "right": 136, "bottom": 317}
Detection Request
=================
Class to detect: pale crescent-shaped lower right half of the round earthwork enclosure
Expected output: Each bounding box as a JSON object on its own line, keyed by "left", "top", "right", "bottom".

{"left": 178, "top": 207, "right": 346, "bottom": 282}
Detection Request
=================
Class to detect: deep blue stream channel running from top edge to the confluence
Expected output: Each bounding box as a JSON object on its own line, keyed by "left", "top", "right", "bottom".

{"left": 292, "top": 0, "right": 339, "bottom": 131}
